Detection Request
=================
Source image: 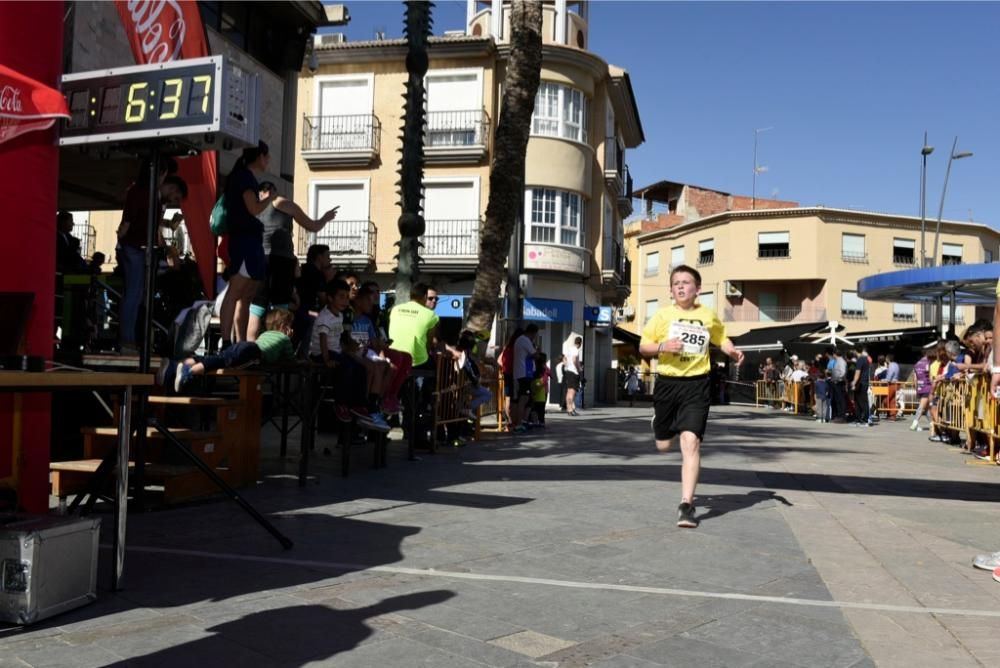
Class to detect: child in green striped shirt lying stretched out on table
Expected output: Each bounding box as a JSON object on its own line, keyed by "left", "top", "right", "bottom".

{"left": 156, "top": 309, "right": 295, "bottom": 393}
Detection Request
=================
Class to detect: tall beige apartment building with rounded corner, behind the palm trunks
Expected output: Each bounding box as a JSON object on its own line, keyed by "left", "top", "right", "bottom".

{"left": 294, "top": 0, "right": 643, "bottom": 398}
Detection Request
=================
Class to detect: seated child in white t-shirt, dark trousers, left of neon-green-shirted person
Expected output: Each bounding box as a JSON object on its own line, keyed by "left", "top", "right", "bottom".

{"left": 309, "top": 280, "right": 389, "bottom": 431}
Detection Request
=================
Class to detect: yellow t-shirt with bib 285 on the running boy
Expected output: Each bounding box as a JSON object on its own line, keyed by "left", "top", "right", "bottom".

{"left": 639, "top": 304, "right": 726, "bottom": 377}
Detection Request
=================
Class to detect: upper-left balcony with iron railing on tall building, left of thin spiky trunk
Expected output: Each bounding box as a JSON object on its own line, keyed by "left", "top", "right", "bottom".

{"left": 302, "top": 114, "right": 382, "bottom": 167}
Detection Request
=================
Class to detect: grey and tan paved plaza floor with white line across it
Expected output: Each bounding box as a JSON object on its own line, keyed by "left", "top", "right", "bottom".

{"left": 0, "top": 406, "right": 1000, "bottom": 668}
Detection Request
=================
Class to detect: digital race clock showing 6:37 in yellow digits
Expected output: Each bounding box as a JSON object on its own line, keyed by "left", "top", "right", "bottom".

{"left": 59, "top": 56, "right": 260, "bottom": 148}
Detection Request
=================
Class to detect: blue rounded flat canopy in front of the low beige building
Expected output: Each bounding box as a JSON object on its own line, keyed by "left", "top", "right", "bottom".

{"left": 858, "top": 263, "right": 1000, "bottom": 306}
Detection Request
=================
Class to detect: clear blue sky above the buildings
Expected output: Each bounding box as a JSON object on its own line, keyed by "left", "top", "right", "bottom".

{"left": 328, "top": 0, "right": 1000, "bottom": 227}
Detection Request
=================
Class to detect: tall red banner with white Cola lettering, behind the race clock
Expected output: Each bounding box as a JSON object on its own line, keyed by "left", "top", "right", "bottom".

{"left": 115, "top": 0, "right": 218, "bottom": 297}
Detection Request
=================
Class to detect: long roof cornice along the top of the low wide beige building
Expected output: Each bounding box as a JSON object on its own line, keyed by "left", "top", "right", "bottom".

{"left": 637, "top": 206, "right": 1000, "bottom": 246}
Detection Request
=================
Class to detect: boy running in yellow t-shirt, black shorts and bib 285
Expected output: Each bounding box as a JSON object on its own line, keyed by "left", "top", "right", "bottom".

{"left": 639, "top": 265, "right": 743, "bottom": 528}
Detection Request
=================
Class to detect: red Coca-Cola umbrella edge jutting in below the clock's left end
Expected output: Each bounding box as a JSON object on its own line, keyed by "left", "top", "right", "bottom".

{"left": 0, "top": 64, "right": 69, "bottom": 144}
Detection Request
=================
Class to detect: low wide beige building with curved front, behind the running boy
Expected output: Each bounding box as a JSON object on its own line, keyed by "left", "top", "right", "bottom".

{"left": 620, "top": 193, "right": 1000, "bottom": 337}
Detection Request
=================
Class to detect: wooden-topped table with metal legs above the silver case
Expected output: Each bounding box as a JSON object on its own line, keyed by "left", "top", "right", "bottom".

{"left": 0, "top": 371, "right": 154, "bottom": 590}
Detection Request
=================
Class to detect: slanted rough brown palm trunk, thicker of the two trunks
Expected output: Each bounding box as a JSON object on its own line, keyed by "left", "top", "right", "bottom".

{"left": 466, "top": 0, "right": 542, "bottom": 332}
